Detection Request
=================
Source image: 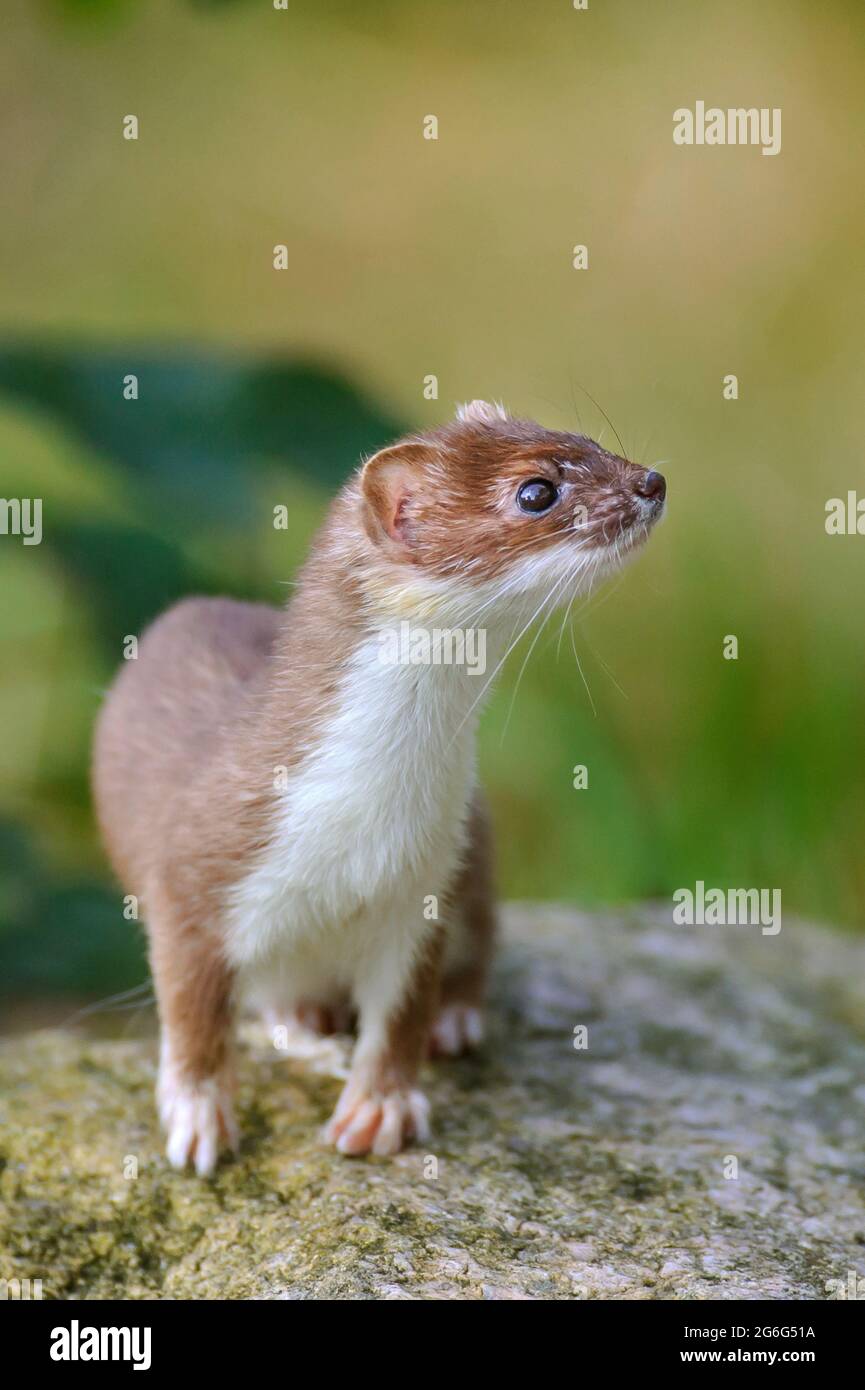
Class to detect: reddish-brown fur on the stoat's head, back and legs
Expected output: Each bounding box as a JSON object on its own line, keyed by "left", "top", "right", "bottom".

{"left": 93, "top": 405, "right": 664, "bottom": 1173}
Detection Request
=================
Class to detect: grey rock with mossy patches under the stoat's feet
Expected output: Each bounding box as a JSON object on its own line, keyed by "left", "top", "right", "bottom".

{"left": 0, "top": 908, "right": 865, "bottom": 1300}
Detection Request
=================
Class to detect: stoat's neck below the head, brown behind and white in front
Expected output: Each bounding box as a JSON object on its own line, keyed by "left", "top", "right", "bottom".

{"left": 257, "top": 503, "right": 510, "bottom": 791}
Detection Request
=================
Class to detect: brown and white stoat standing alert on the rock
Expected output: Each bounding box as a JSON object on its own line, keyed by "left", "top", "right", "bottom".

{"left": 93, "top": 402, "right": 666, "bottom": 1175}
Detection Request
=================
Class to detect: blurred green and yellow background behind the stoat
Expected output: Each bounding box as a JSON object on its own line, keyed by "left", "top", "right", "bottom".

{"left": 0, "top": 0, "right": 865, "bottom": 1027}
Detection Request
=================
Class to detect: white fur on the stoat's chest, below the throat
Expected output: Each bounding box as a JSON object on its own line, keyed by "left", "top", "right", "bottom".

{"left": 225, "top": 637, "right": 484, "bottom": 976}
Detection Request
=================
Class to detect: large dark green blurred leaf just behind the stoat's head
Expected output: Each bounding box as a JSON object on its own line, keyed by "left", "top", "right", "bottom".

{"left": 0, "top": 345, "right": 402, "bottom": 534}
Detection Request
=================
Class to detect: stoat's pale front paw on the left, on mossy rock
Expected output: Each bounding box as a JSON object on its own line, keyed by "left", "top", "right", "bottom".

{"left": 157, "top": 1073, "right": 238, "bottom": 1177}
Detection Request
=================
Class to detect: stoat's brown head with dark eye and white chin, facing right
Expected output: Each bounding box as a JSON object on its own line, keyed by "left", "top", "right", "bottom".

{"left": 360, "top": 400, "right": 666, "bottom": 617}
